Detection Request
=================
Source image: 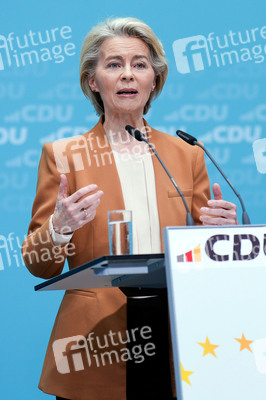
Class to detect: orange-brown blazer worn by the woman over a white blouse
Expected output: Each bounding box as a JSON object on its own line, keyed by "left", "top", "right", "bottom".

{"left": 22, "top": 119, "right": 210, "bottom": 400}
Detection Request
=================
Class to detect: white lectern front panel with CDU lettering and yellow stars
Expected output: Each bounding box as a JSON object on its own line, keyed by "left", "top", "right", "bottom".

{"left": 164, "top": 226, "right": 266, "bottom": 400}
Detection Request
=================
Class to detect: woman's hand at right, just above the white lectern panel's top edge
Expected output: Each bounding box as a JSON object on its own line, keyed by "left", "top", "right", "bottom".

{"left": 199, "top": 183, "right": 237, "bottom": 225}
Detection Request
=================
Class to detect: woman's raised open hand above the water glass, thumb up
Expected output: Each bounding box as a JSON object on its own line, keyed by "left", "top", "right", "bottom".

{"left": 52, "top": 174, "right": 103, "bottom": 234}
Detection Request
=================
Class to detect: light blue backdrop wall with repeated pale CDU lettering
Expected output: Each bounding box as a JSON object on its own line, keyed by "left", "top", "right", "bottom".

{"left": 0, "top": 0, "right": 266, "bottom": 400}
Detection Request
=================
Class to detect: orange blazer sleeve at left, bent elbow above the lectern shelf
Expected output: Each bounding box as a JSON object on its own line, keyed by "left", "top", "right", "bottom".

{"left": 22, "top": 143, "right": 71, "bottom": 279}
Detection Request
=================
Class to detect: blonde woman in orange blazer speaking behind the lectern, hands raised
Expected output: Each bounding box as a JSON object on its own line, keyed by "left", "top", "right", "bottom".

{"left": 23, "top": 18, "right": 236, "bottom": 400}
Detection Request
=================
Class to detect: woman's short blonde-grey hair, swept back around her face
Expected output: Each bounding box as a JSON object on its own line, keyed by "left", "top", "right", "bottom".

{"left": 80, "top": 17, "right": 168, "bottom": 115}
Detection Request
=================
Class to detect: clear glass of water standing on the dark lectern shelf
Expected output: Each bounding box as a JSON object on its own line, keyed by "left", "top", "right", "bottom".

{"left": 108, "top": 210, "right": 133, "bottom": 255}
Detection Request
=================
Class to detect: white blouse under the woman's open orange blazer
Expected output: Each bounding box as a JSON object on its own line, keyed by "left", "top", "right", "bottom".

{"left": 113, "top": 150, "right": 161, "bottom": 254}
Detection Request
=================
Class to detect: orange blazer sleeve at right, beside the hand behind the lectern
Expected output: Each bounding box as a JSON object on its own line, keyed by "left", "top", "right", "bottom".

{"left": 192, "top": 147, "right": 211, "bottom": 225}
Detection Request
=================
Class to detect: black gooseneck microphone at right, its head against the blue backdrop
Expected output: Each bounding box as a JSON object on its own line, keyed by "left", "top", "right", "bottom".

{"left": 176, "top": 130, "right": 250, "bottom": 225}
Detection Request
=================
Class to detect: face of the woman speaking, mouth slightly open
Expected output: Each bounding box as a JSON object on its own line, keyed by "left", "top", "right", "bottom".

{"left": 89, "top": 37, "right": 155, "bottom": 115}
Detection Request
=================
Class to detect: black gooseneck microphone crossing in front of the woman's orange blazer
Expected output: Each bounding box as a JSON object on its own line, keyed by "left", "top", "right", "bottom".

{"left": 125, "top": 125, "right": 195, "bottom": 226}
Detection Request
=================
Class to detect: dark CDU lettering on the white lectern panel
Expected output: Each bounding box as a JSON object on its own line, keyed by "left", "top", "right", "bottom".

{"left": 205, "top": 234, "right": 266, "bottom": 262}
